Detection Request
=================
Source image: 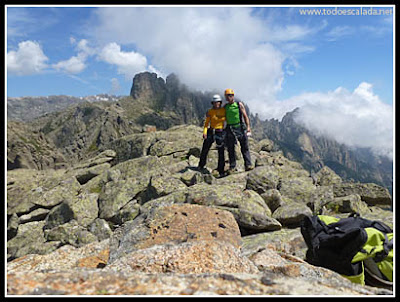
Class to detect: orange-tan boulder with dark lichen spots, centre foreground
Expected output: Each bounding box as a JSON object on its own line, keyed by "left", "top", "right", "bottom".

{"left": 109, "top": 204, "right": 241, "bottom": 263}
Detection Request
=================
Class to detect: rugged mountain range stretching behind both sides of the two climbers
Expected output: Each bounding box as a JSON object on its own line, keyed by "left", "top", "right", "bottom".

{"left": 7, "top": 72, "right": 393, "bottom": 192}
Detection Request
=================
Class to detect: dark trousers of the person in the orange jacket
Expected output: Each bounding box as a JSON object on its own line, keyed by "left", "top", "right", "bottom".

{"left": 199, "top": 128, "right": 225, "bottom": 173}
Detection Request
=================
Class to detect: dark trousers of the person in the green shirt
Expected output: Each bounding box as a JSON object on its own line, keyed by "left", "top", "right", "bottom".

{"left": 226, "top": 126, "right": 251, "bottom": 169}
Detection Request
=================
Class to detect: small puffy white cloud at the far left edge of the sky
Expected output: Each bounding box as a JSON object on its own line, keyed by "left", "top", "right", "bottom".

{"left": 7, "top": 40, "right": 48, "bottom": 75}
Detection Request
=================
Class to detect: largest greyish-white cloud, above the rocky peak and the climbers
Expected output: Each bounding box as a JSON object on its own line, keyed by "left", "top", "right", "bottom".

{"left": 91, "top": 7, "right": 296, "bottom": 100}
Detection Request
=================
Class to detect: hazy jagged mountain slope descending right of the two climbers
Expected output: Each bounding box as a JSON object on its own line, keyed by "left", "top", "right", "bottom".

{"left": 252, "top": 109, "right": 393, "bottom": 192}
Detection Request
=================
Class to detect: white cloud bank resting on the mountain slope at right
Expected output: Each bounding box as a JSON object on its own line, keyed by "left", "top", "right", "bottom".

{"left": 276, "top": 82, "right": 393, "bottom": 158}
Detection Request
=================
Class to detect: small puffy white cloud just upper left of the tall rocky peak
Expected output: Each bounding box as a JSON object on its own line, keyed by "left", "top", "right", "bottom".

{"left": 98, "top": 42, "right": 147, "bottom": 79}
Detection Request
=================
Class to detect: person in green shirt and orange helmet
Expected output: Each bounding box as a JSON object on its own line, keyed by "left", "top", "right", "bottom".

{"left": 224, "top": 89, "right": 254, "bottom": 174}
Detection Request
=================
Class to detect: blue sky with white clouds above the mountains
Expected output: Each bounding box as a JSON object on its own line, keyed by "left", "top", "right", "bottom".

{"left": 6, "top": 6, "right": 394, "bottom": 158}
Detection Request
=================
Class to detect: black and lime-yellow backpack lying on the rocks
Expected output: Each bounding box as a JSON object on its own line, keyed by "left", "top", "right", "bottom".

{"left": 300, "top": 214, "right": 393, "bottom": 290}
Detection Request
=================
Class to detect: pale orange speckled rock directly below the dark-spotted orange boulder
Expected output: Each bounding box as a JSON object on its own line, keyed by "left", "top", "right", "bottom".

{"left": 106, "top": 239, "right": 258, "bottom": 274}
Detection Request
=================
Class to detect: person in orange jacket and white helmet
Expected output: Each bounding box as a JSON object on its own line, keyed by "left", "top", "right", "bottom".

{"left": 198, "top": 94, "right": 226, "bottom": 176}
